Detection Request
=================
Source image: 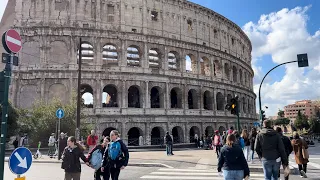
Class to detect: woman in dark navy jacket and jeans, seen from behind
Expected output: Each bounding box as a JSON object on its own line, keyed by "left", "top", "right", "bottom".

{"left": 218, "top": 134, "right": 250, "bottom": 180}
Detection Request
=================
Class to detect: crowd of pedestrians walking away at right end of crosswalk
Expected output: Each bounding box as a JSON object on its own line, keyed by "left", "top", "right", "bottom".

{"left": 216, "top": 120, "right": 309, "bottom": 180}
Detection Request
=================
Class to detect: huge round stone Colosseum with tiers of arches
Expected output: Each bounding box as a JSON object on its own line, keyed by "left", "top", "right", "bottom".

{"left": 0, "top": 0, "right": 256, "bottom": 145}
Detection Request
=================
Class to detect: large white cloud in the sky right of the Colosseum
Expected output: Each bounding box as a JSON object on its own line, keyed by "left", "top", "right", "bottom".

{"left": 243, "top": 6, "right": 320, "bottom": 116}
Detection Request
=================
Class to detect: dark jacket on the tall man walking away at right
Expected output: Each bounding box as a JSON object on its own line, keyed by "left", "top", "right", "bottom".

{"left": 255, "top": 128, "right": 288, "bottom": 165}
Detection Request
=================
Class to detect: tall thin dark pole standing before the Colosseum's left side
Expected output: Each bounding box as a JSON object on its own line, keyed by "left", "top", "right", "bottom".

{"left": 75, "top": 38, "right": 82, "bottom": 140}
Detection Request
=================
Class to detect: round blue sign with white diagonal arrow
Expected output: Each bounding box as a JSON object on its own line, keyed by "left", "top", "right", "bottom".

{"left": 9, "top": 147, "right": 32, "bottom": 175}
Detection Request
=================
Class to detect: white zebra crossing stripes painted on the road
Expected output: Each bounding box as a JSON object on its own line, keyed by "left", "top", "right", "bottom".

{"left": 140, "top": 168, "right": 264, "bottom": 180}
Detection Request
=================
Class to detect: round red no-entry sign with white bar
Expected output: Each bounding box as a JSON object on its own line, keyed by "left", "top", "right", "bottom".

{"left": 2, "top": 29, "right": 22, "bottom": 53}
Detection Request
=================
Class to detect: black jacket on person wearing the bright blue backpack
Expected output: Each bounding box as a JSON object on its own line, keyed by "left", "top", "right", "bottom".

{"left": 102, "top": 139, "right": 129, "bottom": 169}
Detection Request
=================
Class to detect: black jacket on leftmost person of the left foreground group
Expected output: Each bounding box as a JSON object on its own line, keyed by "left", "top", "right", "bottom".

{"left": 61, "top": 147, "right": 87, "bottom": 173}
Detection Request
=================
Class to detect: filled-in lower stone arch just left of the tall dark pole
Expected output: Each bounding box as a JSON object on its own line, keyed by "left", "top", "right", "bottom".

{"left": 48, "top": 83, "right": 69, "bottom": 103}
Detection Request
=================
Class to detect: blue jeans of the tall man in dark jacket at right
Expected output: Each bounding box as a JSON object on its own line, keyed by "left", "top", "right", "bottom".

{"left": 262, "top": 160, "right": 281, "bottom": 180}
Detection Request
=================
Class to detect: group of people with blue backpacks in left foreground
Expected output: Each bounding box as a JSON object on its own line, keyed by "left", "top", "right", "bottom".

{"left": 61, "top": 130, "right": 129, "bottom": 180}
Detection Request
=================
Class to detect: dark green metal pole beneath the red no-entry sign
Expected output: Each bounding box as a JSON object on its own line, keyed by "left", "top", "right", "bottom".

{"left": 0, "top": 53, "right": 14, "bottom": 180}
